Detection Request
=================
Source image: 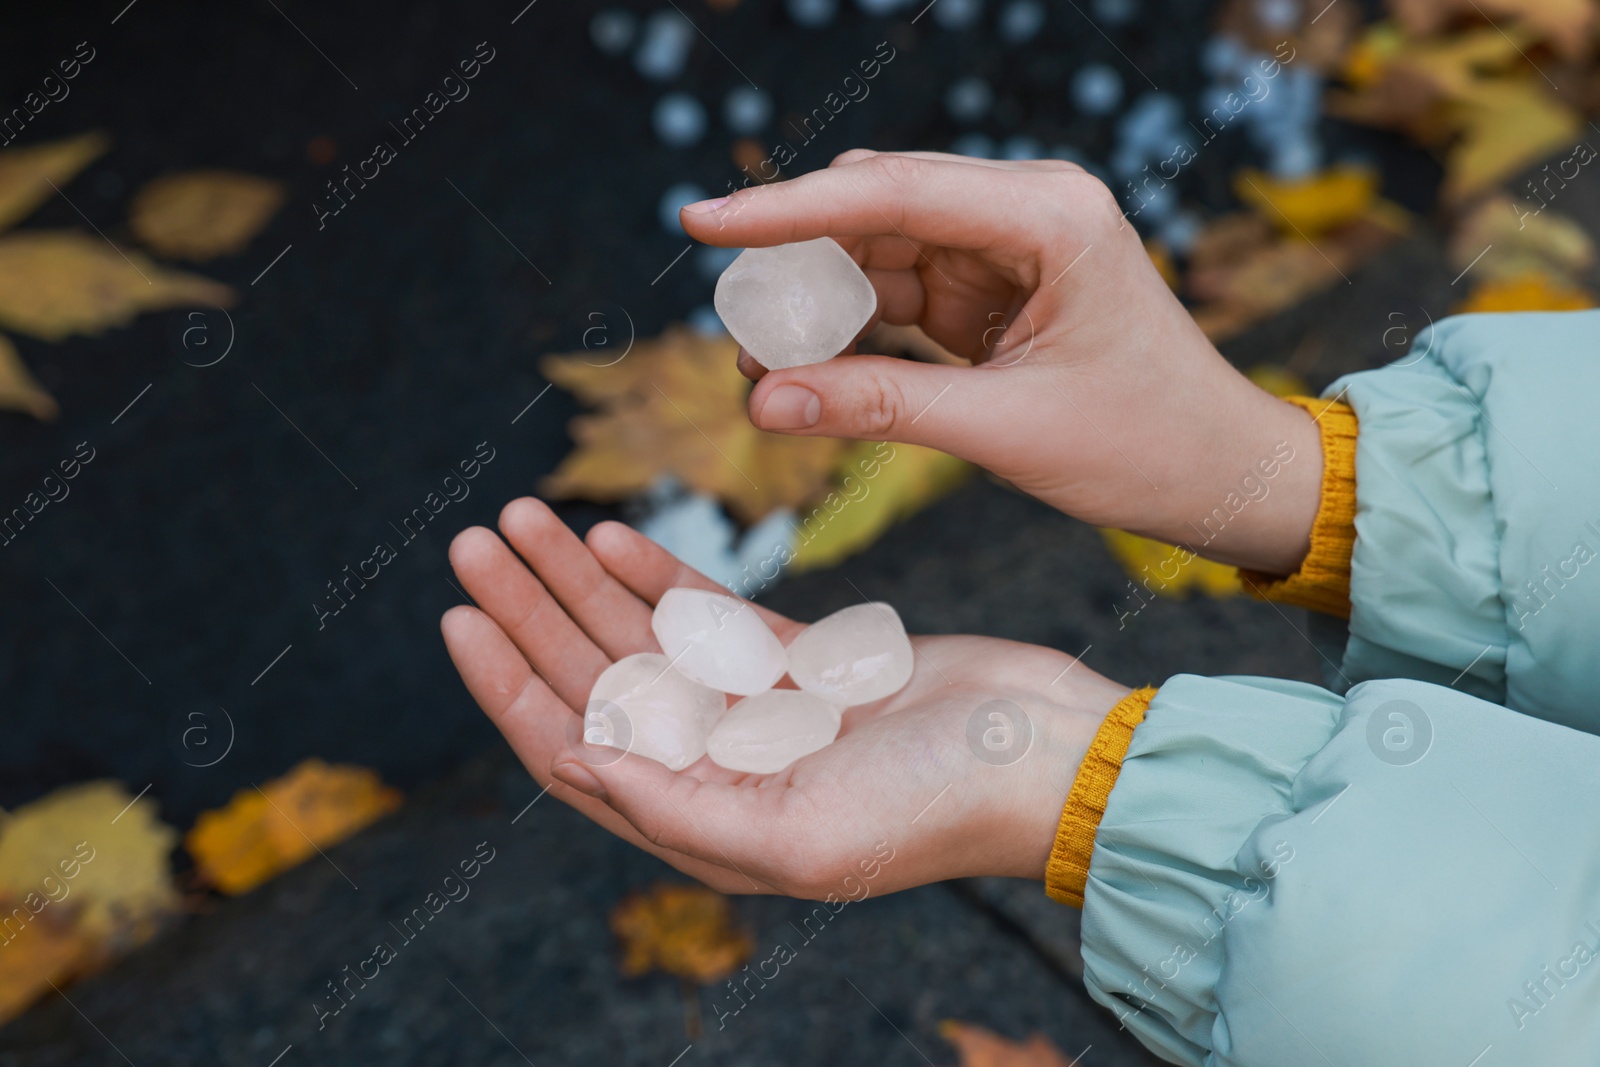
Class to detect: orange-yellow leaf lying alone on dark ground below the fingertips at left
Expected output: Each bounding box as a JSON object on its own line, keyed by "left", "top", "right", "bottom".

{"left": 184, "top": 760, "right": 400, "bottom": 894}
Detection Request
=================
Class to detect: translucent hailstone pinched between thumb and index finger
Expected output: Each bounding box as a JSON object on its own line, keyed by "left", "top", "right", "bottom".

{"left": 714, "top": 237, "right": 878, "bottom": 370}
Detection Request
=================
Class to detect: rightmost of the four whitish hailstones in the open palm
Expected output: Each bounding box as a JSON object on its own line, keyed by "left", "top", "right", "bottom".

{"left": 789, "top": 603, "right": 912, "bottom": 707}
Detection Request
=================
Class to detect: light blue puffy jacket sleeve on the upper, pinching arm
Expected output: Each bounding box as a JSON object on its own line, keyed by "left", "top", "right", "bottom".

{"left": 1326, "top": 303, "right": 1600, "bottom": 731}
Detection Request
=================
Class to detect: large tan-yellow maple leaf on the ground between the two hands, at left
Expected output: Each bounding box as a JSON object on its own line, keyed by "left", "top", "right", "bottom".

{"left": 539, "top": 326, "right": 845, "bottom": 522}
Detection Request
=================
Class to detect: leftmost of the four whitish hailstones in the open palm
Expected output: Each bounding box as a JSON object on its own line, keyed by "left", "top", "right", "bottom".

{"left": 584, "top": 653, "right": 728, "bottom": 771}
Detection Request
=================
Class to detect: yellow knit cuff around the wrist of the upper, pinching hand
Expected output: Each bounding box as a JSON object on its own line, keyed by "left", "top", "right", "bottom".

{"left": 1238, "top": 397, "right": 1358, "bottom": 619}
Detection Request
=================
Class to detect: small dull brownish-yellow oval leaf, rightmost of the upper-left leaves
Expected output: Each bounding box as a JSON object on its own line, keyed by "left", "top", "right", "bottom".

{"left": 128, "top": 170, "right": 283, "bottom": 259}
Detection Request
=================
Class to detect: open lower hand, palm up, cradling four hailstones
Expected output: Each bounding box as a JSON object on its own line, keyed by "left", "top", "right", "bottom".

{"left": 442, "top": 499, "right": 1128, "bottom": 899}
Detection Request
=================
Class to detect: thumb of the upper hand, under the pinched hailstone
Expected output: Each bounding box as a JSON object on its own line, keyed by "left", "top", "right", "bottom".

{"left": 750, "top": 355, "right": 995, "bottom": 459}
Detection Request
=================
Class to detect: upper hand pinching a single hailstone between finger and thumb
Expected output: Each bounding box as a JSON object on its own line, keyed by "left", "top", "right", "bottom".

{"left": 682, "top": 150, "right": 1322, "bottom": 574}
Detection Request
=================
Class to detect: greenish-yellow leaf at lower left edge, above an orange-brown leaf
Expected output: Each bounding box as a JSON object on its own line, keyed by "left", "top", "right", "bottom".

{"left": 0, "top": 781, "right": 178, "bottom": 952}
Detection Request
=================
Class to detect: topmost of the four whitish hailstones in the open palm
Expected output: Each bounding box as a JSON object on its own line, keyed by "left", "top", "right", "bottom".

{"left": 650, "top": 589, "right": 789, "bottom": 696}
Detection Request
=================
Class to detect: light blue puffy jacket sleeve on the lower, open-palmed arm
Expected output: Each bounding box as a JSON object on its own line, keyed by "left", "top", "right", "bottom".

{"left": 1083, "top": 675, "right": 1600, "bottom": 1067}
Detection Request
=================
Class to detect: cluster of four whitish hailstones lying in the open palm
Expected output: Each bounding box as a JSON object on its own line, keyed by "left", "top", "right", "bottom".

{"left": 584, "top": 589, "right": 912, "bottom": 774}
